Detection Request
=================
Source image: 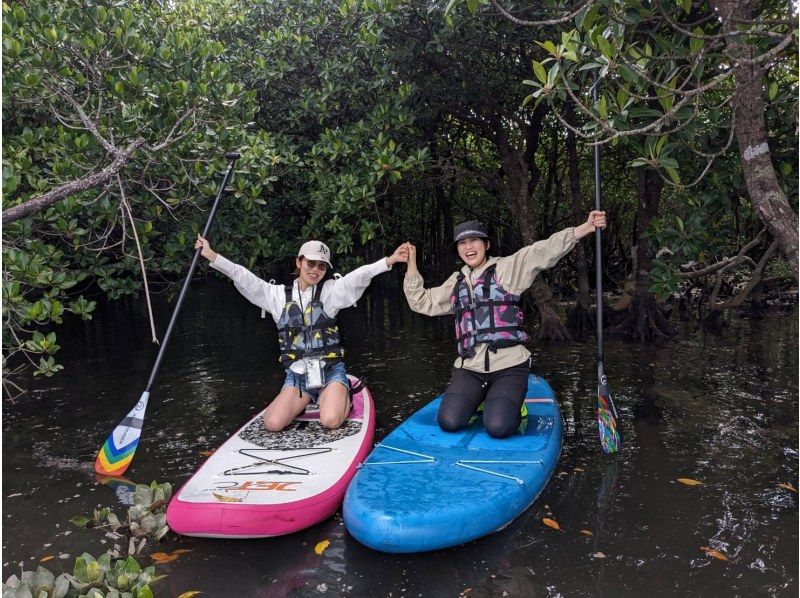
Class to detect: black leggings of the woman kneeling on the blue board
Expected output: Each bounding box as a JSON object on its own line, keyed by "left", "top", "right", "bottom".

{"left": 437, "top": 362, "right": 530, "bottom": 438}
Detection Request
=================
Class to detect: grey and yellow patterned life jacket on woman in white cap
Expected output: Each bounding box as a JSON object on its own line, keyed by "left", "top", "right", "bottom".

{"left": 278, "top": 285, "right": 344, "bottom": 368}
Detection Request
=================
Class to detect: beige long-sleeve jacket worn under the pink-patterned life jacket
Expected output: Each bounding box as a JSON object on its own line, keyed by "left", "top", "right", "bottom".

{"left": 403, "top": 227, "right": 578, "bottom": 372}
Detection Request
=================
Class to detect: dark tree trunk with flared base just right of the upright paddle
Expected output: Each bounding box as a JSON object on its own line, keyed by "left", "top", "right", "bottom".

{"left": 609, "top": 167, "right": 675, "bottom": 342}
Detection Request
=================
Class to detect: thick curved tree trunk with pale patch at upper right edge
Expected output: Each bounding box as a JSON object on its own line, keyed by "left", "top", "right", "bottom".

{"left": 712, "top": 0, "right": 798, "bottom": 280}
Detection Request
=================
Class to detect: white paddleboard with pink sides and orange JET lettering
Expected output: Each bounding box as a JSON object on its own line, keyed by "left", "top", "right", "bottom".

{"left": 167, "top": 376, "right": 375, "bottom": 538}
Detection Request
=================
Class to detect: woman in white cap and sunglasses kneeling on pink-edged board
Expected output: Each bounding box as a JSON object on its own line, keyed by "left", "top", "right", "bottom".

{"left": 195, "top": 235, "right": 408, "bottom": 432}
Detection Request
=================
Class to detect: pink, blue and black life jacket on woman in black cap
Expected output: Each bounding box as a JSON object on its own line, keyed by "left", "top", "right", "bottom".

{"left": 450, "top": 264, "right": 528, "bottom": 371}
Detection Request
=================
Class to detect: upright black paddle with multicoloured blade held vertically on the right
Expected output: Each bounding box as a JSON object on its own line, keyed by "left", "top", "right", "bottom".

{"left": 592, "top": 76, "right": 622, "bottom": 460}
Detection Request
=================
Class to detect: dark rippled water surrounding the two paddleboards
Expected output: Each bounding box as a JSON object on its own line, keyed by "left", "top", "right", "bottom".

{"left": 2, "top": 280, "right": 798, "bottom": 597}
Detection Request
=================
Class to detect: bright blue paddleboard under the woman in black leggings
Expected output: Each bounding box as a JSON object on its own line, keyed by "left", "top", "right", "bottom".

{"left": 343, "top": 375, "right": 563, "bottom": 553}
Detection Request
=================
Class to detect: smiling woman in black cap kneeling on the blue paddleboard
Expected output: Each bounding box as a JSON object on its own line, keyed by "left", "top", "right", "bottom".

{"left": 403, "top": 211, "right": 606, "bottom": 438}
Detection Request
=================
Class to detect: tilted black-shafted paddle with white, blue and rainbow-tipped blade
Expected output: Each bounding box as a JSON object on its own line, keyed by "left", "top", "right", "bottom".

{"left": 94, "top": 152, "right": 240, "bottom": 476}
